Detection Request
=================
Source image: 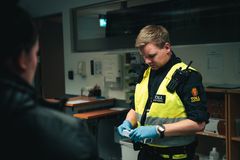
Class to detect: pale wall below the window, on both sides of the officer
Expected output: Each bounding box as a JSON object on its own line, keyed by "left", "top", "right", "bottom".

{"left": 65, "top": 42, "right": 240, "bottom": 99}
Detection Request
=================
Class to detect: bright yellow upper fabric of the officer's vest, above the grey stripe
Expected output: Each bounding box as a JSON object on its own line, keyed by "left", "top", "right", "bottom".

{"left": 135, "top": 63, "right": 189, "bottom": 119}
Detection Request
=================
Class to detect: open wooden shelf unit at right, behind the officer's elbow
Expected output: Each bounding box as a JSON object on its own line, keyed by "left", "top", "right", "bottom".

{"left": 197, "top": 88, "right": 240, "bottom": 160}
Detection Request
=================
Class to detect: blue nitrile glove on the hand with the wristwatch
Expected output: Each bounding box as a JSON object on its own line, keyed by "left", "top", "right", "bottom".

{"left": 129, "top": 125, "right": 159, "bottom": 142}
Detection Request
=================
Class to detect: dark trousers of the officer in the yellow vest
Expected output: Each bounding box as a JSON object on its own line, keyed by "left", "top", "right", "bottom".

{"left": 138, "top": 143, "right": 196, "bottom": 160}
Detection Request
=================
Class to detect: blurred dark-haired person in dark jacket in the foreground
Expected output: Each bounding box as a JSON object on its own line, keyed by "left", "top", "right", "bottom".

{"left": 0, "top": 1, "right": 97, "bottom": 160}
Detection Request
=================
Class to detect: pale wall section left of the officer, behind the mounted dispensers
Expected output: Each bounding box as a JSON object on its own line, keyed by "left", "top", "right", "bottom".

{"left": 62, "top": 51, "right": 129, "bottom": 99}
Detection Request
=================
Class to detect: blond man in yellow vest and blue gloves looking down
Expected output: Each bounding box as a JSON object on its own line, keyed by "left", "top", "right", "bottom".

{"left": 118, "top": 25, "right": 209, "bottom": 160}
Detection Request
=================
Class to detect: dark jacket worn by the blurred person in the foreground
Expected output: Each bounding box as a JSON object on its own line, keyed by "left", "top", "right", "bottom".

{"left": 0, "top": 71, "right": 97, "bottom": 160}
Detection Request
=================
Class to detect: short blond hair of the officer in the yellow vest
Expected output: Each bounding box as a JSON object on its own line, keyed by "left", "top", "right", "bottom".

{"left": 135, "top": 25, "right": 170, "bottom": 48}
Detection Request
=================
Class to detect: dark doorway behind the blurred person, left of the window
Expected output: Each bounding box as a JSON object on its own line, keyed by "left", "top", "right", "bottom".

{"left": 35, "top": 14, "right": 65, "bottom": 98}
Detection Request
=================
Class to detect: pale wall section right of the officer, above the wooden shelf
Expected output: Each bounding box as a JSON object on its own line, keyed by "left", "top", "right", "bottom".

{"left": 173, "top": 42, "right": 240, "bottom": 86}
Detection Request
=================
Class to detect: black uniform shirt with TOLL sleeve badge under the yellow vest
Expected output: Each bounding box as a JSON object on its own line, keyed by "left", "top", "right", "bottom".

{"left": 131, "top": 53, "right": 209, "bottom": 122}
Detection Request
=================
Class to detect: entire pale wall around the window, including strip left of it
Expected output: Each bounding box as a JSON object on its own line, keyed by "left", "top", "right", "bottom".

{"left": 20, "top": 0, "right": 240, "bottom": 99}
